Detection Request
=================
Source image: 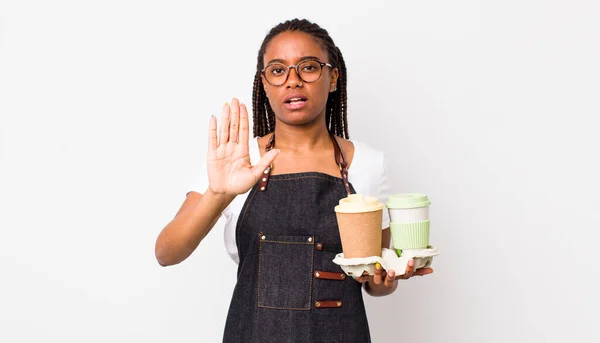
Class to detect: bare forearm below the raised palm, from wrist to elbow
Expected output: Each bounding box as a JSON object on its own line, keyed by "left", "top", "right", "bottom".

{"left": 154, "top": 189, "right": 234, "bottom": 267}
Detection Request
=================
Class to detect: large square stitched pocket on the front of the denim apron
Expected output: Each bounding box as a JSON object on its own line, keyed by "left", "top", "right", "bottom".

{"left": 258, "top": 233, "right": 314, "bottom": 310}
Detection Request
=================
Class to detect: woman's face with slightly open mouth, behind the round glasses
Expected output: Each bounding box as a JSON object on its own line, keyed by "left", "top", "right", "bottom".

{"left": 262, "top": 31, "right": 338, "bottom": 125}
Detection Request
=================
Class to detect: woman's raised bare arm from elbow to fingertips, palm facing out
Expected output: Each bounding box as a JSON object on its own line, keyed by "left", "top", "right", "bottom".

{"left": 154, "top": 98, "right": 279, "bottom": 266}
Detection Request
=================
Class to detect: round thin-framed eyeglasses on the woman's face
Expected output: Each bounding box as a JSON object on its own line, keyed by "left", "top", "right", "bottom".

{"left": 261, "top": 60, "right": 333, "bottom": 87}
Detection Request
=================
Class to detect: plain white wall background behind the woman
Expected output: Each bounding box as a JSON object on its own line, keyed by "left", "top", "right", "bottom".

{"left": 0, "top": 0, "right": 600, "bottom": 343}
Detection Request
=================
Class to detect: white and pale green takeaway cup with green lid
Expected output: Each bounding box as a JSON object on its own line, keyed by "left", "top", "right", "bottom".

{"left": 386, "top": 193, "right": 431, "bottom": 250}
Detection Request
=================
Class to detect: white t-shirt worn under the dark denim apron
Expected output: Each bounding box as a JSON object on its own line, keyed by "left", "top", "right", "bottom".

{"left": 190, "top": 138, "right": 391, "bottom": 263}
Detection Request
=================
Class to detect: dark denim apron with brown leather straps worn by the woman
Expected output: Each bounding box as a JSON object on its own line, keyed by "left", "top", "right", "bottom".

{"left": 223, "top": 135, "right": 371, "bottom": 343}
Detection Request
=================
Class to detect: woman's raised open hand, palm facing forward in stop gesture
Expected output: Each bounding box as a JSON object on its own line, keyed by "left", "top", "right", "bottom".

{"left": 207, "top": 98, "right": 279, "bottom": 196}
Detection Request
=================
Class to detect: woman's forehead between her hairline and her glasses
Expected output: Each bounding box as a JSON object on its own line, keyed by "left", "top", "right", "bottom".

{"left": 263, "top": 31, "right": 329, "bottom": 65}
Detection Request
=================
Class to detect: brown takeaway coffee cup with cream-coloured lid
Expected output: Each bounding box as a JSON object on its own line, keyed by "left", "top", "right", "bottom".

{"left": 335, "top": 194, "right": 384, "bottom": 258}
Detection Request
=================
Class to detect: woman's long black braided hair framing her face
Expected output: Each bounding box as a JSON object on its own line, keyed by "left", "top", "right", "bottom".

{"left": 252, "top": 19, "right": 350, "bottom": 139}
